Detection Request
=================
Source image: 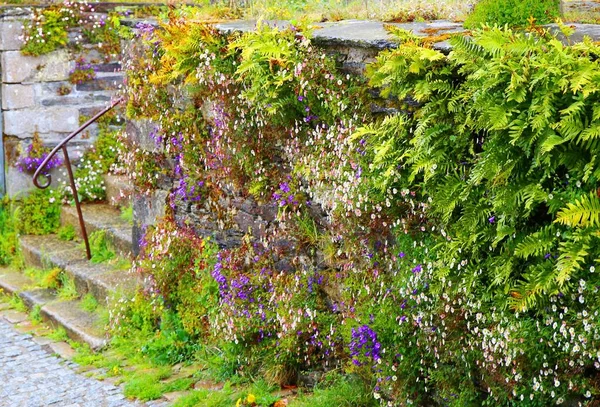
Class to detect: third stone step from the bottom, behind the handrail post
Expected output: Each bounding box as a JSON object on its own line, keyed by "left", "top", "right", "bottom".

{"left": 60, "top": 203, "right": 133, "bottom": 257}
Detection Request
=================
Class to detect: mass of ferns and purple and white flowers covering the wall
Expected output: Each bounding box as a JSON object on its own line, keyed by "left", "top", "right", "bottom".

{"left": 116, "top": 13, "right": 600, "bottom": 406}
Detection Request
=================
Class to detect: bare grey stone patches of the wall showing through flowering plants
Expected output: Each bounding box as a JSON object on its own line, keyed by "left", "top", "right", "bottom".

{"left": 127, "top": 20, "right": 600, "bottom": 256}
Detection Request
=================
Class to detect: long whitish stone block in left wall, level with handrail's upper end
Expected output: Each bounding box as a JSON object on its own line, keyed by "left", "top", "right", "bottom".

{"left": 4, "top": 107, "right": 79, "bottom": 138}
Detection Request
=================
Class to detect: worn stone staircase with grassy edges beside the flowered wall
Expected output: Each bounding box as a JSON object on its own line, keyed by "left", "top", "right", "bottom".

{"left": 0, "top": 178, "right": 141, "bottom": 350}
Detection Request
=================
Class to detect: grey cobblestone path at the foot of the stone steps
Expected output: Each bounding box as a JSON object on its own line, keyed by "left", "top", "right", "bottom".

{"left": 0, "top": 317, "right": 141, "bottom": 407}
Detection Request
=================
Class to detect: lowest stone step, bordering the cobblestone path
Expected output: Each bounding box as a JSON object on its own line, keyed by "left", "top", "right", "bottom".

{"left": 0, "top": 269, "right": 108, "bottom": 350}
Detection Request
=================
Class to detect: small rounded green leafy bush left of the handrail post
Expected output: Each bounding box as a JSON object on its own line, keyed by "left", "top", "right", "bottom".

{"left": 15, "top": 189, "right": 60, "bottom": 235}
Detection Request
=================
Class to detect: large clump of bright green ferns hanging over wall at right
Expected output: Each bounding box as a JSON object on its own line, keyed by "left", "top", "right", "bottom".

{"left": 364, "top": 28, "right": 599, "bottom": 309}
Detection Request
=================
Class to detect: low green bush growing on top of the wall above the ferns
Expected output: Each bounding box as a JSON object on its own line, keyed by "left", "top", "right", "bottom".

{"left": 465, "top": 0, "right": 560, "bottom": 28}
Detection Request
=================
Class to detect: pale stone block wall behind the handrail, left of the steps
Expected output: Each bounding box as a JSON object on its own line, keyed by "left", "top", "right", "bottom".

{"left": 0, "top": 7, "right": 123, "bottom": 196}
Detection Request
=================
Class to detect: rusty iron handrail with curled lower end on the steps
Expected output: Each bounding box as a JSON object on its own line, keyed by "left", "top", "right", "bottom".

{"left": 33, "top": 98, "right": 123, "bottom": 260}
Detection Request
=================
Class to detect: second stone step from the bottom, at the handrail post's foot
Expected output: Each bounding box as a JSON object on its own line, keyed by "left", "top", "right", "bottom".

{"left": 20, "top": 235, "right": 141, "bottom": 304}
